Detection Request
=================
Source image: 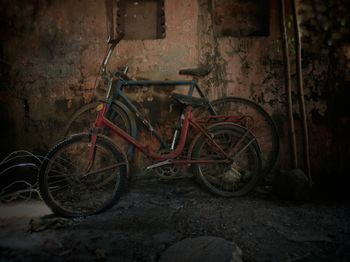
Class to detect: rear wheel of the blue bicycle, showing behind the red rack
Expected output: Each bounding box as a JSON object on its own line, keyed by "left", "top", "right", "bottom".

{"left": 210, "top": 96, "right": 280, "bottom": 177}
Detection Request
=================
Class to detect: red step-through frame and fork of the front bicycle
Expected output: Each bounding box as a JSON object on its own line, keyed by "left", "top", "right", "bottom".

{"left": 89, "top": 104, "right": 230, "bottom": 165}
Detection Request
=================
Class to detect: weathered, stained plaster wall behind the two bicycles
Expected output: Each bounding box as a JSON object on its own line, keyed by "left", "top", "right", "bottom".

{"left": 0, "top": 0, "right": 349, "bottom": 188}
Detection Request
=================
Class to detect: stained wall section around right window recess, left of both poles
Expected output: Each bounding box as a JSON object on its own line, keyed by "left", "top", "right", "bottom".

{"left": 198, "top": 0, "right": 289, "bottom": 167}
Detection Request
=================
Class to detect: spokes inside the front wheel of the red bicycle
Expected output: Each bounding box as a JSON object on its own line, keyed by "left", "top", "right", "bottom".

{"left": 43, "top": 137, "right": 126, "bottom": 215}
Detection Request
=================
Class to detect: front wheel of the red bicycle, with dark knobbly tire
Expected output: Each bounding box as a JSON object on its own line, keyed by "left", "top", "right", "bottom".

{"left": 38, "top": 133, "right": 128, "bottom": 217}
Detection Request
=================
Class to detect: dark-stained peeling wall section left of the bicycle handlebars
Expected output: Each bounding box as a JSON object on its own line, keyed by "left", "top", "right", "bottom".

{"left": 1, "top": 0, "right": 105, "bottom": 156}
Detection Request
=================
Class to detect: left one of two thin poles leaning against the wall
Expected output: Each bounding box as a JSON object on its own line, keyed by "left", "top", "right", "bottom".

{"left": 280, "top": 0, "right": 298, "bottom": 168}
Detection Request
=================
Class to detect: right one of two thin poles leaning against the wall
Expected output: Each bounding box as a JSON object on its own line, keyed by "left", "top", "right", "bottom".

{"left": 292, "top": 0, "right": 312, "bottom": 186}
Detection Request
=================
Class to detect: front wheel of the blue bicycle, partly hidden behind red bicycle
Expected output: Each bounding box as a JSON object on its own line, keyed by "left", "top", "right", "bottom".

{"left": 63, "top": 102, "right": 132, "bottom": 154}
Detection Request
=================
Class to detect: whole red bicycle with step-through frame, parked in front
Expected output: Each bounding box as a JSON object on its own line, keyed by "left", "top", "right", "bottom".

{"left": 39, "top": 90, "right": 261, "bottom": 217}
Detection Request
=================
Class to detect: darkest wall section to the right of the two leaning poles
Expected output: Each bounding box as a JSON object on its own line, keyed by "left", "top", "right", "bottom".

{"left": 299, "top": 0, "right": 350, "bottom": 192}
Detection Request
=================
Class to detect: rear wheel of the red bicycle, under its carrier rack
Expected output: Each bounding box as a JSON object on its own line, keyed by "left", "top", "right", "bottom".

{"left": 192, "top": 123, "right": 262, "bottom": 197}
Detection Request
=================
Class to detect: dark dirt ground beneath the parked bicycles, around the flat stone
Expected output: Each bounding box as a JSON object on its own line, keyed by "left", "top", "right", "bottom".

{"left": 0, "top": 178, "right": 350, "bottom": 261}
